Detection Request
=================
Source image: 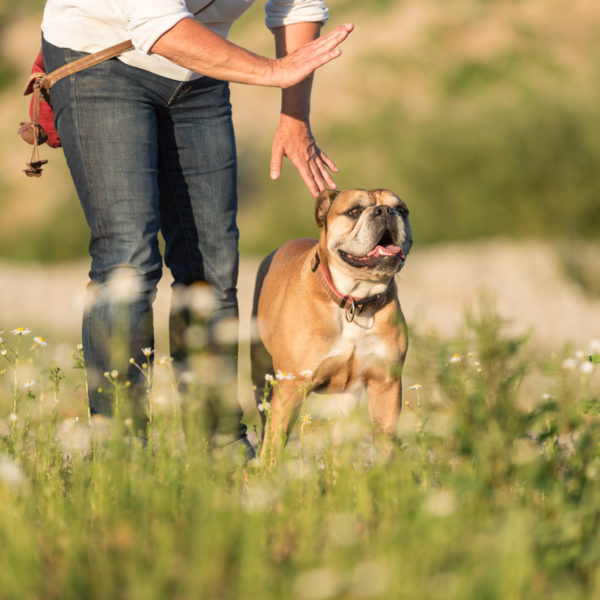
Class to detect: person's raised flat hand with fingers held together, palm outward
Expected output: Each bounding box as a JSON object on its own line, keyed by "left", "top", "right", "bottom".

{"left": 270, "top": 23, "right": 354, "bottom": 89}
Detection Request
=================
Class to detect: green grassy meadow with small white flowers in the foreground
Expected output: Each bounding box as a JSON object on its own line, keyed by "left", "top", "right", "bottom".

{"left": 0, "top": 308, "right": 600, "bottom": 600}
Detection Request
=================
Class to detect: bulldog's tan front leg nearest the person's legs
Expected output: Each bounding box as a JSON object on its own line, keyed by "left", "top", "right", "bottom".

{"left": 260, "top": 380, "right": 304, "bottom": 468}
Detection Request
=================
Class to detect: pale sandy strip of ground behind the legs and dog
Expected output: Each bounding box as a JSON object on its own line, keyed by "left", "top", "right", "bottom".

{"left": 0, "top": 241, "right": 600, "bottom": 351}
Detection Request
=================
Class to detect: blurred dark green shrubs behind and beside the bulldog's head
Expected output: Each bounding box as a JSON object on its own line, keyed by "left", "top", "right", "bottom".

{"left": 243, "top": 89, "right": 600, "bottom": 251}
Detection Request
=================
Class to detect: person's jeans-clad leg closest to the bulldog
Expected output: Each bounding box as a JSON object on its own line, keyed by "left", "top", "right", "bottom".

{"left": 159, "top": 78, "right": 245, "bottom": 443}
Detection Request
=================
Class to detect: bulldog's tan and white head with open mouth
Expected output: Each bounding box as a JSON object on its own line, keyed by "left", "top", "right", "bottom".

{"left": 315, "top": 189, "right": 412, "bottom": 281}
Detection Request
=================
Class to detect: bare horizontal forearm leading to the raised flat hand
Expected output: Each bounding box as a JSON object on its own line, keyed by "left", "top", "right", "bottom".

{"left": 151, "top": 18, "right": 277, "bottom": 86}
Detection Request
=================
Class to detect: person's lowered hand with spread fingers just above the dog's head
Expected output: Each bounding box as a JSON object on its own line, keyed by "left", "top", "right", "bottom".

{"left": 270, "top": 114, "right": 338, "bottom": 198}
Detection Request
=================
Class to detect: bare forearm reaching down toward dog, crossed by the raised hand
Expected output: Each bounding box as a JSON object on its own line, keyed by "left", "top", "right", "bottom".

{"left": 275, "top": 23, "right": 321, "bottom": 121}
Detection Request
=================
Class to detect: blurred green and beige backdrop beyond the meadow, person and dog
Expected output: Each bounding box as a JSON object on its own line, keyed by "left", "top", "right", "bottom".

{"left": 0, "top": 0, "right": 600, "bottom": 348}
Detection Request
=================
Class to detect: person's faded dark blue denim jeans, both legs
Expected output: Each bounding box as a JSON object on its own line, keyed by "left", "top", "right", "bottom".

{"left": 42, "top": 40, "right": 245, "bottom": 435}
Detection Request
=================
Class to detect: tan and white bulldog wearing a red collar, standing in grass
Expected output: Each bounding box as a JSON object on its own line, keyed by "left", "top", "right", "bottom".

{"left": 251, "top": 189, "right": 412, "bottom": 458}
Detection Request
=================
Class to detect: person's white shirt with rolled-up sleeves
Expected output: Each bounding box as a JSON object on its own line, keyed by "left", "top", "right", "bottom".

{"left": 42, "top": 0, "right": 329, "bottom": 81}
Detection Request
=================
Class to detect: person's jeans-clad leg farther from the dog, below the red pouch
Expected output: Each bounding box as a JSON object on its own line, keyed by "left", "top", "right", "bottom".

{"left": 43, "top": 38, "right": 169, "bottom": 432}
